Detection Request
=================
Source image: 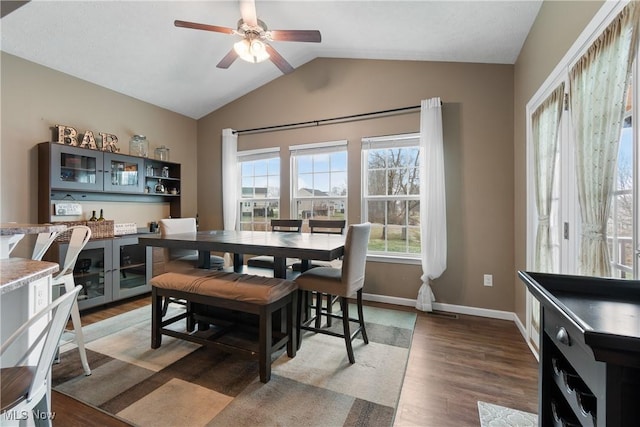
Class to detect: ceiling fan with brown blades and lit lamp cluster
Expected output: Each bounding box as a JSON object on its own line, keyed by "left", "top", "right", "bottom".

{"left": 174, "top": 0, "right": 322, "bottom": 74}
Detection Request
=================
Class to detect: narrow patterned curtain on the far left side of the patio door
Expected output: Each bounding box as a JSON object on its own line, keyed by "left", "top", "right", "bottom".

{"left": 531, "top": 83, "right": 564, "bottom": 273}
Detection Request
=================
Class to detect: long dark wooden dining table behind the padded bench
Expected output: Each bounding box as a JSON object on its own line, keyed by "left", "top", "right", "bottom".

{"left": 139, "top": 230, "right": 345, "bottom": 278}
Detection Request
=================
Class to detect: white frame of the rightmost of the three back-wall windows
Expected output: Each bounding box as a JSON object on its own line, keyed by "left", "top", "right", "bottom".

{"left": 361, "top": 132, "right": 424, "bottom": 265}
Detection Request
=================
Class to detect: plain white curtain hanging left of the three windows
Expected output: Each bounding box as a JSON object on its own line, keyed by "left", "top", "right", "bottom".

{"left": 222, "top": 128, "right": 238, "bottom": 266}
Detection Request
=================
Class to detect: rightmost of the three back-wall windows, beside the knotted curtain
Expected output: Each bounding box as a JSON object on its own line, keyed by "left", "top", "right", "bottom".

{"left": 362, "top": 134, "right": 420, "bottom": 258}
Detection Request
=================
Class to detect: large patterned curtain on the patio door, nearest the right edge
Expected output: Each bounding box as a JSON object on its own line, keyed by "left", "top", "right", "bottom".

{"left": 570, "top": 2, "right": 640, "bottom": 277}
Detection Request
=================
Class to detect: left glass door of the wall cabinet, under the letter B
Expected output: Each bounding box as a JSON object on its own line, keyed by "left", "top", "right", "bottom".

{"left": 51, "top": 144, "right": 104, "bottom": 190}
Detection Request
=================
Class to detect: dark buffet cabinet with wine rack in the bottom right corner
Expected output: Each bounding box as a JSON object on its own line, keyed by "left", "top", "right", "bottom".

{"left": 518, "top": 272, "right": 640, "bottom": 427}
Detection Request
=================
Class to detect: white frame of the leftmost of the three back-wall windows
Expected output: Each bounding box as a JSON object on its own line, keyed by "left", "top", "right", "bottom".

{"left": 236, "top": 147, "right": 282, "bottom": 231}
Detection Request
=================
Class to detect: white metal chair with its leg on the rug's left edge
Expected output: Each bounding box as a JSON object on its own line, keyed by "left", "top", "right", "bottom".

{"left": 53, "top": 225, "right": 91, "bottom": 375}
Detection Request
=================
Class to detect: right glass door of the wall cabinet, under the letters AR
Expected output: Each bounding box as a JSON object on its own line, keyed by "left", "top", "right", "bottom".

{"left": 104, "top": 153, "right": 144, "bottom": 193}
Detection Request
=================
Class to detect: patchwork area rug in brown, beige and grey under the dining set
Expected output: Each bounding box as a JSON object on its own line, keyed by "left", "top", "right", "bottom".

{"left": 52, "top": 305, "right": 416, "bottom": 427}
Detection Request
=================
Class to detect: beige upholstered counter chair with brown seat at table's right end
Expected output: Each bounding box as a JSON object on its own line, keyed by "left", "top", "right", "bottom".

{"left": 294, "top": 222, "right": 371, "bottom": 363}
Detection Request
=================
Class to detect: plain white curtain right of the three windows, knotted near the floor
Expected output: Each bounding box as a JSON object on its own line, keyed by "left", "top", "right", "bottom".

{"left": 416, "top": 98, "right": 447, "bottom": 311}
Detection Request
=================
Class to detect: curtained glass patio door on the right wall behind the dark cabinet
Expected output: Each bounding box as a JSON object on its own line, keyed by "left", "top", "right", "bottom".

{"left": 526, "top": 4, "right": 640, "bottom": 358}
